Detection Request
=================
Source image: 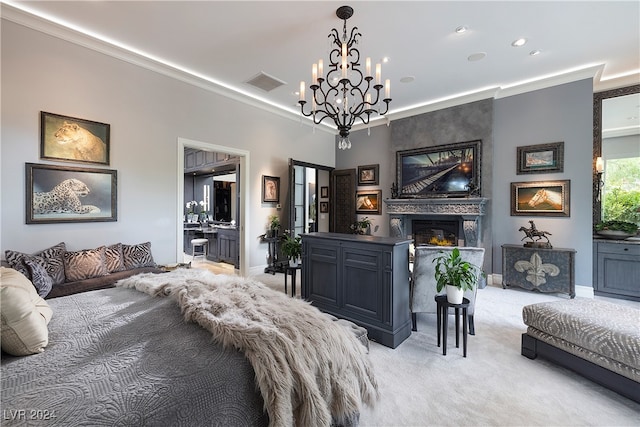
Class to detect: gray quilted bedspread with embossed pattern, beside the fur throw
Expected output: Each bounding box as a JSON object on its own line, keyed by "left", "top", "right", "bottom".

{"left": 0, "top": 288, "right": 268, "bottom": 426}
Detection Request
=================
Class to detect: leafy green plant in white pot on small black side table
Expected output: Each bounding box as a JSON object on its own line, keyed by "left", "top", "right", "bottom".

{"left": 433, "top": 248, "right": 480, "bottom": 304}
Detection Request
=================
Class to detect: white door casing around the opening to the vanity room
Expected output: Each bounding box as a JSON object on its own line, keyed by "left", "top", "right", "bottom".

{"left": 176, "top": 138, "right": 250, "bottom": 277}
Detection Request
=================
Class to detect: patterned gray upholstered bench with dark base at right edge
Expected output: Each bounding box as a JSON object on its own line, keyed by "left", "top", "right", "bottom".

{"left": 522, "top": 298, "right": 640, "bottom": 402}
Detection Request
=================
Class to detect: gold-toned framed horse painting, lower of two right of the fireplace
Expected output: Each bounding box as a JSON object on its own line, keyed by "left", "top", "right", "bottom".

{"left": 511, "top": 179, "right": 571, "bottom": 216}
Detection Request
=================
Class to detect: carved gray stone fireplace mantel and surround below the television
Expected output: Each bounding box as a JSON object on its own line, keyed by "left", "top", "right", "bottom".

{"left": 384, "top": 197, "right": 489, "bottom": 247}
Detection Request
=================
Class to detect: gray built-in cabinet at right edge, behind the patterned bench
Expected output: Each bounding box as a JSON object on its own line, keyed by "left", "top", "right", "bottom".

{"left": 593, "top": 239, "right": 640, "bottom": 301}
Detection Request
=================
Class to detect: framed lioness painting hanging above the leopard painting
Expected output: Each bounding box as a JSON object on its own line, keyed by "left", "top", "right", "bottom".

{"left": 40, "top": 111, "right": 111, "bottom": 165}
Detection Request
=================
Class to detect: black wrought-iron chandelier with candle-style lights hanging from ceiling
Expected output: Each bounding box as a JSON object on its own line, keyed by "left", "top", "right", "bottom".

{"left": 298, "top": 6, "right": 391, "bottom": 150}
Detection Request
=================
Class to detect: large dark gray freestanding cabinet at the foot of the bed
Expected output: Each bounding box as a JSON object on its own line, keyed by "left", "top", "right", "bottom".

{"left": 302, "top": 233, "right": 411, "bottom": 348}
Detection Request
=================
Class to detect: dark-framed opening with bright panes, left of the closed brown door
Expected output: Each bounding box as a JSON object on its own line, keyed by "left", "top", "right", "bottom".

{"left": 287, "top": 159, "right": 332, "bottom": 235}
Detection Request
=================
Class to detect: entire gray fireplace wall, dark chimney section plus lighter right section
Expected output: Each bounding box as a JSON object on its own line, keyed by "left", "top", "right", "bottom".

{"left": 336, "top": 79, "right": 593, "bottom": 294}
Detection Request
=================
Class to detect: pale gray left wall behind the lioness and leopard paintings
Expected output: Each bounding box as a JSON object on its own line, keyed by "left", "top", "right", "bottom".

{"left": 0, "top": 19, "right": 334, "bottom": 271}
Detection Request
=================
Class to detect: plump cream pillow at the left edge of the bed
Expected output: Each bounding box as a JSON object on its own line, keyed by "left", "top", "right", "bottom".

{"left": 0, "top": 267, "right": 53, "bottom": 356}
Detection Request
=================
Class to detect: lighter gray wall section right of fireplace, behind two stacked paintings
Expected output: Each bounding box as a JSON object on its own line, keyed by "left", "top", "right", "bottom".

{"left": 493, "top": 79, "right": 593, "bottom": 287}
